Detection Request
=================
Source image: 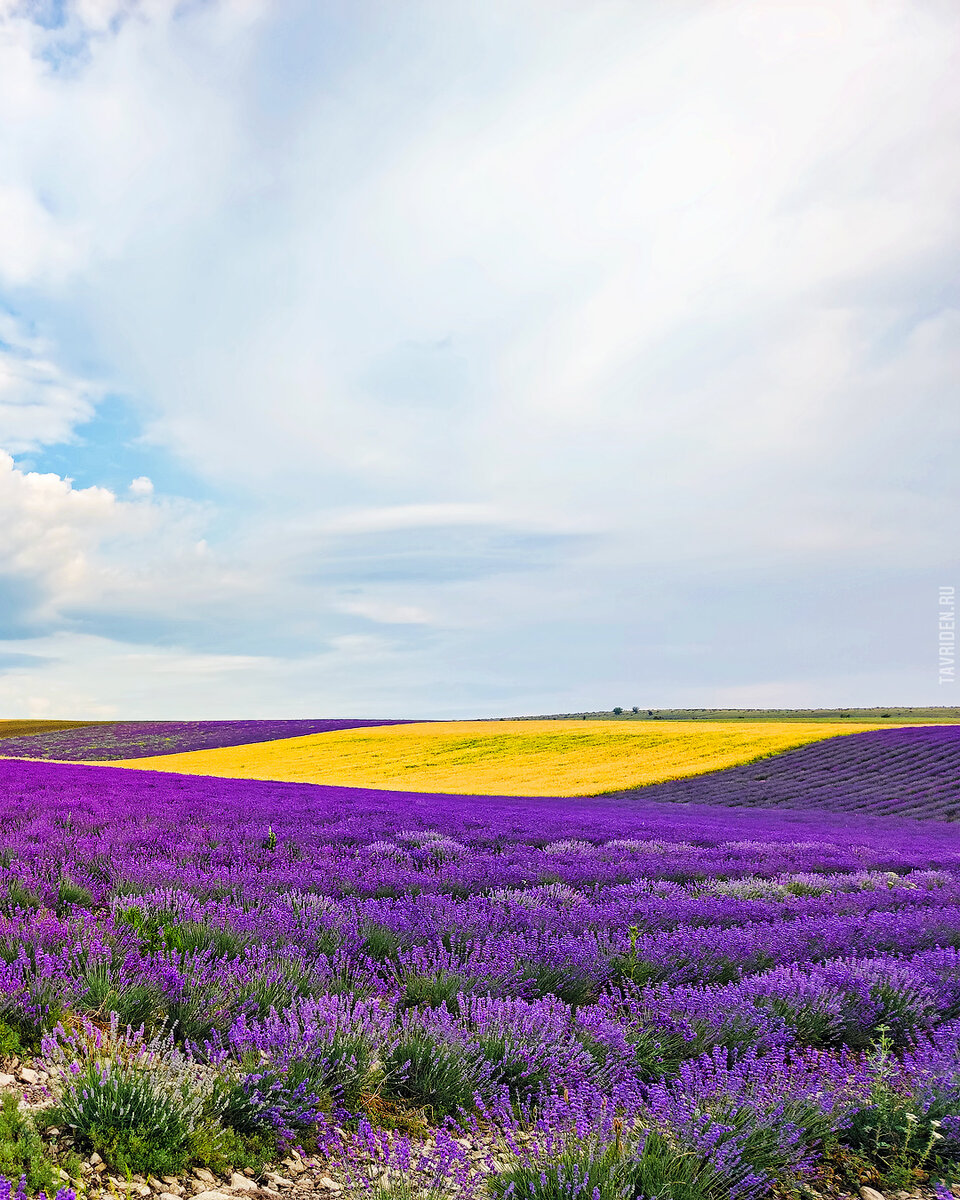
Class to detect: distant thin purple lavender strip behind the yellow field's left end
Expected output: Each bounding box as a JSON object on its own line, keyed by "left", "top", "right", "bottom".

{"left": 0, "top": 720, "right": 409, "bottom": 762}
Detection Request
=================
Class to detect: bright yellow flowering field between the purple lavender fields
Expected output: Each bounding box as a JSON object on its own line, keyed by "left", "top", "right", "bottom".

{"left": 100, "top": 721, "right": 881, "bottom": 796}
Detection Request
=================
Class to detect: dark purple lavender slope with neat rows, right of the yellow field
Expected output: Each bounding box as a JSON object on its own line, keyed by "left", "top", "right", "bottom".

{"left": 624, "top": 725, "right": 960, "bottom": 821}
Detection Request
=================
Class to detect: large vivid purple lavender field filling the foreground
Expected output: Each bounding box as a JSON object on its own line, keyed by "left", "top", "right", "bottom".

{"left": 0, "top": 748, "right": 960, "bottom": 1200}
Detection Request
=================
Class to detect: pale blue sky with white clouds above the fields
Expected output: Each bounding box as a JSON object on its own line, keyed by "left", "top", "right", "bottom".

{"left": 0, "top": 0, "right": 960, "bottom": 719}
